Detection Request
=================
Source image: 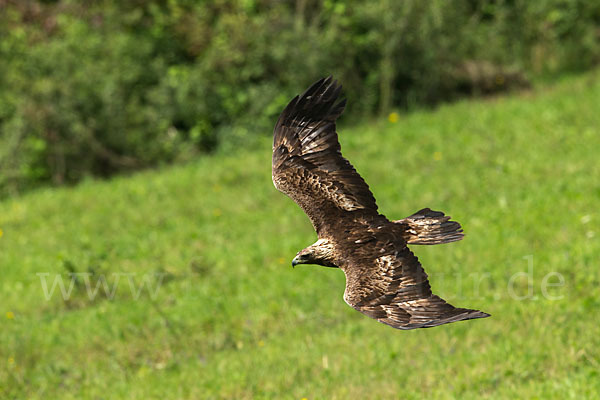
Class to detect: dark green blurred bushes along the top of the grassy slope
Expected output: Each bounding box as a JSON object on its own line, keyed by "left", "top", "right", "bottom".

{"left": 0, "top": 0, "right": 600, "bottom": 196}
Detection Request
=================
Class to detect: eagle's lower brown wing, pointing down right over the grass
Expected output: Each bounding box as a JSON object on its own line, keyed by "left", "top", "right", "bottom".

{"left": 344, "top": 245, "right": 489, "bottom": 329}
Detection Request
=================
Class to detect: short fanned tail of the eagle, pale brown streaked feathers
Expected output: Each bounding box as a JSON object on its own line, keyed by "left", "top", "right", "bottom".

{"left": 394, "top": 208, "right": 465, "bottom": 245}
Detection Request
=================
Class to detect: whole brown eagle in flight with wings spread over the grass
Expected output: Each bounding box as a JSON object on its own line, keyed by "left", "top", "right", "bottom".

{"left": 272, "top": 77, "right": 489, "bottom": 329}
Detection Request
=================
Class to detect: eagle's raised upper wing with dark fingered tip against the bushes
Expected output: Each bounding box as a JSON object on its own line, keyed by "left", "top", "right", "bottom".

{"left": 273, "top": 77, "right": 377, "bottom": 234}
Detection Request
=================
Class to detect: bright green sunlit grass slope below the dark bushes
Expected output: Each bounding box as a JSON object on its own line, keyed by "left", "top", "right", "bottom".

{"left": 0, "top": 73, "right": 600, "bottom": 399}
